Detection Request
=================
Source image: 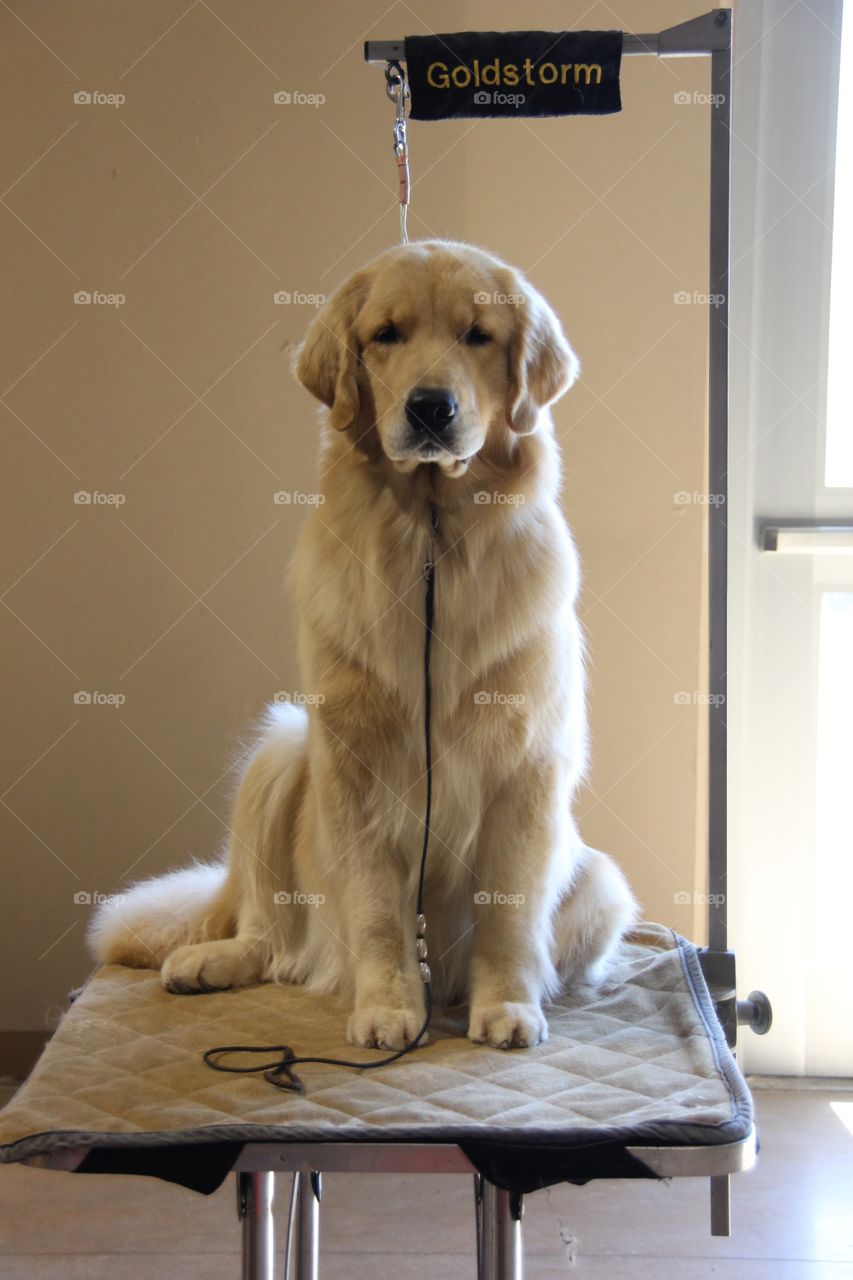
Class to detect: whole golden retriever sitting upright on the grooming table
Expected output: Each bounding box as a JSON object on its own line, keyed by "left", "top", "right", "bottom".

{"left": 90, "top": 241, "right": 635, "bottom": 1050}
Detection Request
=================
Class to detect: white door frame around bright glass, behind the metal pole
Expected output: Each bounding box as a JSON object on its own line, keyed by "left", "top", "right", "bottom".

{"left": 727, "top": 0, "right": 853, "bottom": 1074}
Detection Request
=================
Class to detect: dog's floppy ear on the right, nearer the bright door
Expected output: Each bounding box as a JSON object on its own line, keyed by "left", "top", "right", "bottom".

{"left": 507, "top": 280, "right": 580, "bottom": 435}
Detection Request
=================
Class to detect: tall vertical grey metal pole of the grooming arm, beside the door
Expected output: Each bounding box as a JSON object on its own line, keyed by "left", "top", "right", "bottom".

{"left": 708, "top": 9, "right": 731, "bottom": 951}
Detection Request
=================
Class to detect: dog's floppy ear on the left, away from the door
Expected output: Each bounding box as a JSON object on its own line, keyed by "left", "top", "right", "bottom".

{"left": 293, "top": 273, "right": 368, "bottom": 431}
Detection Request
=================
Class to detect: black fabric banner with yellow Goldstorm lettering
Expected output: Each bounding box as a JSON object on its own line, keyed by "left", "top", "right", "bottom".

{"left": 406, "top": 31, "right": 622, "bottom": 120}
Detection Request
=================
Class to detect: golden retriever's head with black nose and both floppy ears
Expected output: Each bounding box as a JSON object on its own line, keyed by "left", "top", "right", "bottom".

{"left": 296, "top": 241, "right": 578, "bottom": 476}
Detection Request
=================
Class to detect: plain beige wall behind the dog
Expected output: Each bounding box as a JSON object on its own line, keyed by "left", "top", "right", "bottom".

{"left": 0, "top": 0, "right": 707, "bottom": 1049}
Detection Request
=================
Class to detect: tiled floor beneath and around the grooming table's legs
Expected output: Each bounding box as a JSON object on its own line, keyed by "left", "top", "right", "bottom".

{"left": 0, "top": 1088, "right": 853, "bottom": 1280}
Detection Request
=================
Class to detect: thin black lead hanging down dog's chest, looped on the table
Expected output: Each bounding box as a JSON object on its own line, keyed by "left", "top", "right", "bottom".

{"left": 202, "top": 503, "right": 438, "bottom": 1093}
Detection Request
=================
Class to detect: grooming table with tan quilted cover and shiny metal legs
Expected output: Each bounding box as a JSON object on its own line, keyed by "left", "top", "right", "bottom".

{"left": 0, "top": 924, "right": 756, "bottom": 1280}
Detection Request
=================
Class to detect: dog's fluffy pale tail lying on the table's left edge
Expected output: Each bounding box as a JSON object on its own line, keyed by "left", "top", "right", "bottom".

{"left": 87, "top": 863, "right": 236, "bottom": 969}
